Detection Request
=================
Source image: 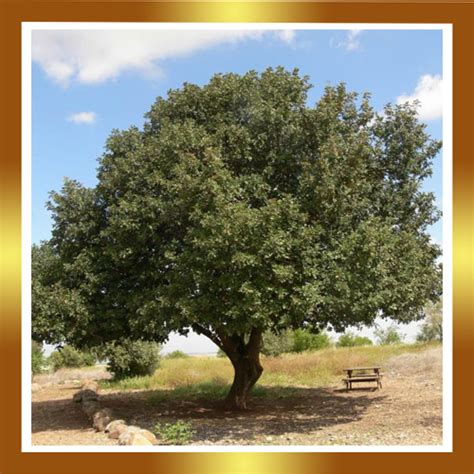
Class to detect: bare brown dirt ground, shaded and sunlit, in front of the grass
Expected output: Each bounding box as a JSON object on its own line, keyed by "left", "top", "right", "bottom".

{"left": 32, "top": 348, "right": 442, "bottom": 445}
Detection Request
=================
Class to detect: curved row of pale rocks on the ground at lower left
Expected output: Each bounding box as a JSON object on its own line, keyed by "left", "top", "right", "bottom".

{"left": 73, "top": 380, "right": 158, "bottom": 446}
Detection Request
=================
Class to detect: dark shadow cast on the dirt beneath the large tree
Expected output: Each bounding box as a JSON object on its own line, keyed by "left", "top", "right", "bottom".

{"left": 32, "top": 387, "right": 385, "bottom": 443}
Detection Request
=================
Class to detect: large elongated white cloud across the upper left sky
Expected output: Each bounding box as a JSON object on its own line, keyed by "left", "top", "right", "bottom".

{"left": 32, "top": 30, "right": 294, "bottom": 85}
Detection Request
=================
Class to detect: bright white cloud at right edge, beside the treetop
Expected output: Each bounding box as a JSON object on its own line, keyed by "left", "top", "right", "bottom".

{"left": 397, "top": 74, "right": 443, "bottom": 120}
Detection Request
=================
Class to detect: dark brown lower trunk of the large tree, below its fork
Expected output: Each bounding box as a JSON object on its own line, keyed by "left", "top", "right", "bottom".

{"left": 225, "top": 354, "right": 263, "bottom": 410}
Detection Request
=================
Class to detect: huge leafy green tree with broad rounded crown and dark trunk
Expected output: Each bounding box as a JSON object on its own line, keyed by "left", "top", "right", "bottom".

{"left": 33, "top": 67, "right": 441, "bottom": 409}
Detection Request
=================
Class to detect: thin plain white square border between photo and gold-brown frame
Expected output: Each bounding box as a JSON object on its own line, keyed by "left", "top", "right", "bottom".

{"left": 21, "top": 22, "right": 453, "bottom": 453}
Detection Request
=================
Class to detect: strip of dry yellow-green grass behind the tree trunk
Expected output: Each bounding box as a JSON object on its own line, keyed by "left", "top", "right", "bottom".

{"left": 100, "top": 344, "right": 436, "bottom": 401}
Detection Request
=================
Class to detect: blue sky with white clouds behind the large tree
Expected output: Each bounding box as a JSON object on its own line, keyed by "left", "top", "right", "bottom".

{"left": 32, "top": 26, "right": 442, "bottom": 352}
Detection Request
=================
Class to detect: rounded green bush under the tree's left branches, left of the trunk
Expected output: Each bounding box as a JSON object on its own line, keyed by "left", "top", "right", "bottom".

{"left": 105, "top": 339, "right": 160, "bottom": 379}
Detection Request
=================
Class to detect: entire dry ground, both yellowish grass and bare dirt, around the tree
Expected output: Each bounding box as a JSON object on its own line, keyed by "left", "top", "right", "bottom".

{"left": 33, "top": 345, "right": 442, "bottom": 445}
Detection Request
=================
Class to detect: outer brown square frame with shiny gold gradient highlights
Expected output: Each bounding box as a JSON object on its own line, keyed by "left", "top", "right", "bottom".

{"left": 0, "top": 0, "right": 474, "bottom": 474}
